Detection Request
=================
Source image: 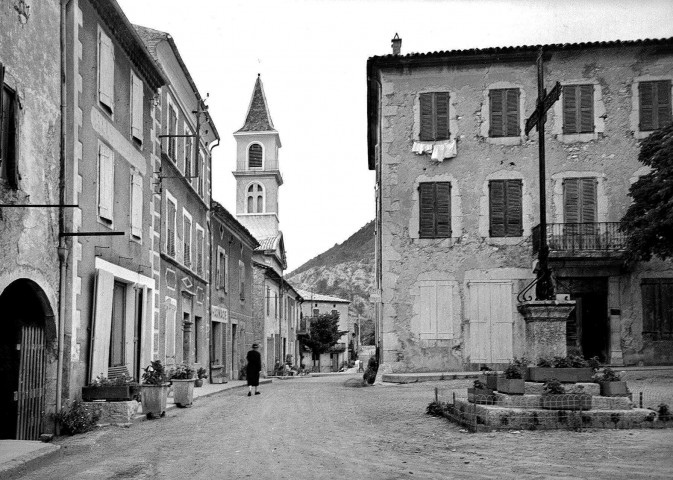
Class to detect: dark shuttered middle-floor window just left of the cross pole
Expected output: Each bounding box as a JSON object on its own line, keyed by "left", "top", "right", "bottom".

{"left": 488, "top": 180, "right": 523, "bottom": 237}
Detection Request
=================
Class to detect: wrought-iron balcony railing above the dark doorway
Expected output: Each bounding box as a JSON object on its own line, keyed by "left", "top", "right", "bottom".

{"left": 533, "top": 222, "right": 626, "bottom": 254}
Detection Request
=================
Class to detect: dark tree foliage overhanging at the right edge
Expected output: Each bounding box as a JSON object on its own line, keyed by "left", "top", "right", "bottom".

{"left": 621, "top": 125, "right": 673, "bottom": 261}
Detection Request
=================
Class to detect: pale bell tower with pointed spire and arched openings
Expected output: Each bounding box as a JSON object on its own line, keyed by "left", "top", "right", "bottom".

{"left": 233, "top": 74, "right": 283, "bottom": 240}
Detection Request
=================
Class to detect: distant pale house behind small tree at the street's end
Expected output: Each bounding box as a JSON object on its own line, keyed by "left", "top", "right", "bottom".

{"left": 297, "top": 289, "right": 357, "bottom": 372}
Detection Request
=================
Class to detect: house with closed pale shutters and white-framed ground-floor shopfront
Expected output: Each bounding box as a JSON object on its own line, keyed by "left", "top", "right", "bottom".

{"left": 63, "top": 0, "right": 166, "bottom": 399}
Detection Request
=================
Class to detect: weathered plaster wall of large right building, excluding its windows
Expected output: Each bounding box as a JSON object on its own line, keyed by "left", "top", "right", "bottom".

{"left": 380, "top": 47, "right": 673, "bottom": 371}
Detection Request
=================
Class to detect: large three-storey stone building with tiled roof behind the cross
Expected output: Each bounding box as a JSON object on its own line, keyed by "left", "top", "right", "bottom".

{"left": 367, "top": 39, "right": 673, "bottom": 372}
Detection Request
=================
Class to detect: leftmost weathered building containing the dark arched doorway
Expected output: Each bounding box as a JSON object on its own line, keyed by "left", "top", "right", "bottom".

{"left": 0, "top": 0, "right": 61, "bottom": 440}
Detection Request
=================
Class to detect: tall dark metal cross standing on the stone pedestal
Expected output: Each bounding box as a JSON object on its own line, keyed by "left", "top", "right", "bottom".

{"left": 525, "top": 48, "right": 561, "bottom": 300}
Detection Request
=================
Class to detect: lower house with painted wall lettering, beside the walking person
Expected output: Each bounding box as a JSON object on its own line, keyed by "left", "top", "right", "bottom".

{"left": 210, "top": 200, "right": 259, "bottom": 383}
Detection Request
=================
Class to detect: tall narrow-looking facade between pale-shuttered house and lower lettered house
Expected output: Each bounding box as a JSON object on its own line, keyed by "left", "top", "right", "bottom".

{"left": 135, "top": 26, "right": 219, "bottom": 376}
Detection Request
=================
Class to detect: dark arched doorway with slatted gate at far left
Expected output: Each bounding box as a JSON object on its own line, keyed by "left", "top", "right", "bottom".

{"left": 0, "top": 279, "right": 56, "bottom": 440}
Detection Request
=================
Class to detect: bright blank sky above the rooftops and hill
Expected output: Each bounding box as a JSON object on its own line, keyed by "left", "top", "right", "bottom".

{"left": 117, "top": 0, "right": 673, "bottom": 272}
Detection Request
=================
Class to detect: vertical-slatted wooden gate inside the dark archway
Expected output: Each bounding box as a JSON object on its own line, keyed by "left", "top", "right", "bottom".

{"left": 16, "top": 325, "right": 45, "bottom": 440}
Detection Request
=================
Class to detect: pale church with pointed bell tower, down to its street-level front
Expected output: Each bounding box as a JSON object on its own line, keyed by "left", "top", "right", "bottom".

{"left": 233, "top": 77, "right": 300, "bottom": 374}
